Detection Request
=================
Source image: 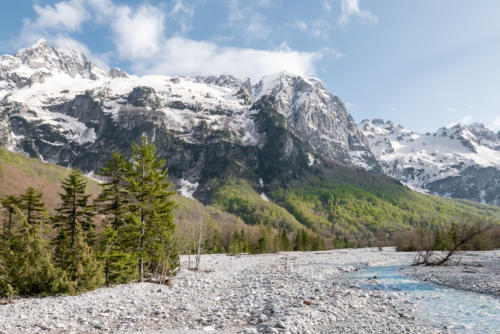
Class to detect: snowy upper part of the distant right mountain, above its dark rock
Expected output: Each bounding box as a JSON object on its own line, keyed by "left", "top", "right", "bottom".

{"left": 359, "top": 119, "right": 500, "bottom": 192}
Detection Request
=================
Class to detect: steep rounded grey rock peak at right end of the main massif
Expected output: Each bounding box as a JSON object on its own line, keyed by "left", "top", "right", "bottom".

{"left": 253, "top": 72, "right": 379, "bottom": 171}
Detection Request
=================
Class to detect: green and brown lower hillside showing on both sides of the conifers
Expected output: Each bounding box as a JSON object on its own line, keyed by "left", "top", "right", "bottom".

{"left": 0, "top": 148, "right": 500, "bottom": 248}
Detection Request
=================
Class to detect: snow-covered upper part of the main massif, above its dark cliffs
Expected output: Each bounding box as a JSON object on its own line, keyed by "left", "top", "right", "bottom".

{"left": 0, "top": 40, "right": 378, "bottom": 170}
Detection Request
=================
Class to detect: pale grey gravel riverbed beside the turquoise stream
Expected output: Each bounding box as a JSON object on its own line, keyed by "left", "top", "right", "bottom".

{"left": 0, "top": 248, "right": 500, "bottom": 333}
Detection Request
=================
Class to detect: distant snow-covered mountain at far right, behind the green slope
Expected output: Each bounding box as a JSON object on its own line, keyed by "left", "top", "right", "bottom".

{"left": 358, "top": 119, "right": 500, "bottom": 205}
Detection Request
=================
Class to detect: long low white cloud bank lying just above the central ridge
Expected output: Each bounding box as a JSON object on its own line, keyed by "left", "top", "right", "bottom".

{"left": 134, "top": 37, "right": 322, "bottom": 81}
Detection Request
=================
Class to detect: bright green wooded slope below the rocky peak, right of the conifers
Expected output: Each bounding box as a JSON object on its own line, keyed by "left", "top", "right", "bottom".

{"left": 212, "top": 177, "right": 500, "bottom": 247}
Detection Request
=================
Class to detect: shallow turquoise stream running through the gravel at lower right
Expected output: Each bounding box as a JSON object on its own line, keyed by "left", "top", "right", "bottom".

{"left": 350, "top": 266, "right": 500, "bottom": 334}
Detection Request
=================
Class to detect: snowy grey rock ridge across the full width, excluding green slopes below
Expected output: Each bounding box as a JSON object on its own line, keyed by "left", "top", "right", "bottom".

{"left": 0, "top": 40, "right": 500, "bottom": 205}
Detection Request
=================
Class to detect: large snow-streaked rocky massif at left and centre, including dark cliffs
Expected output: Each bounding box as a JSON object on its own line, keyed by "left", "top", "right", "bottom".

{"left": 0, "top": 40, "right": 380, "bottom": 200}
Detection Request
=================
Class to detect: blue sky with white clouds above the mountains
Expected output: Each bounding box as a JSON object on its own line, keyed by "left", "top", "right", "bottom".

{"left": 0, "top": 0, "right": 500, "bottom": 131}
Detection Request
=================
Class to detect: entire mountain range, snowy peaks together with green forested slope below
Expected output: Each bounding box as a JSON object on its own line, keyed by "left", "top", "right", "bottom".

{"left": 0, "top": 40, "right": 500, "bottom": 245}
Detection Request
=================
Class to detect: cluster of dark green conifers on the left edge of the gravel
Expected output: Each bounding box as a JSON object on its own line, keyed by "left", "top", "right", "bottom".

{"left": 0, "top": 137, "right": 179, "bottom": 297}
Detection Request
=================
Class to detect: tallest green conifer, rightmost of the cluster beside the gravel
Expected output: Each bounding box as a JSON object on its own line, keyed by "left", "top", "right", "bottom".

{"left": 126, "top": 136, "right": 179, "bottom": 281}
